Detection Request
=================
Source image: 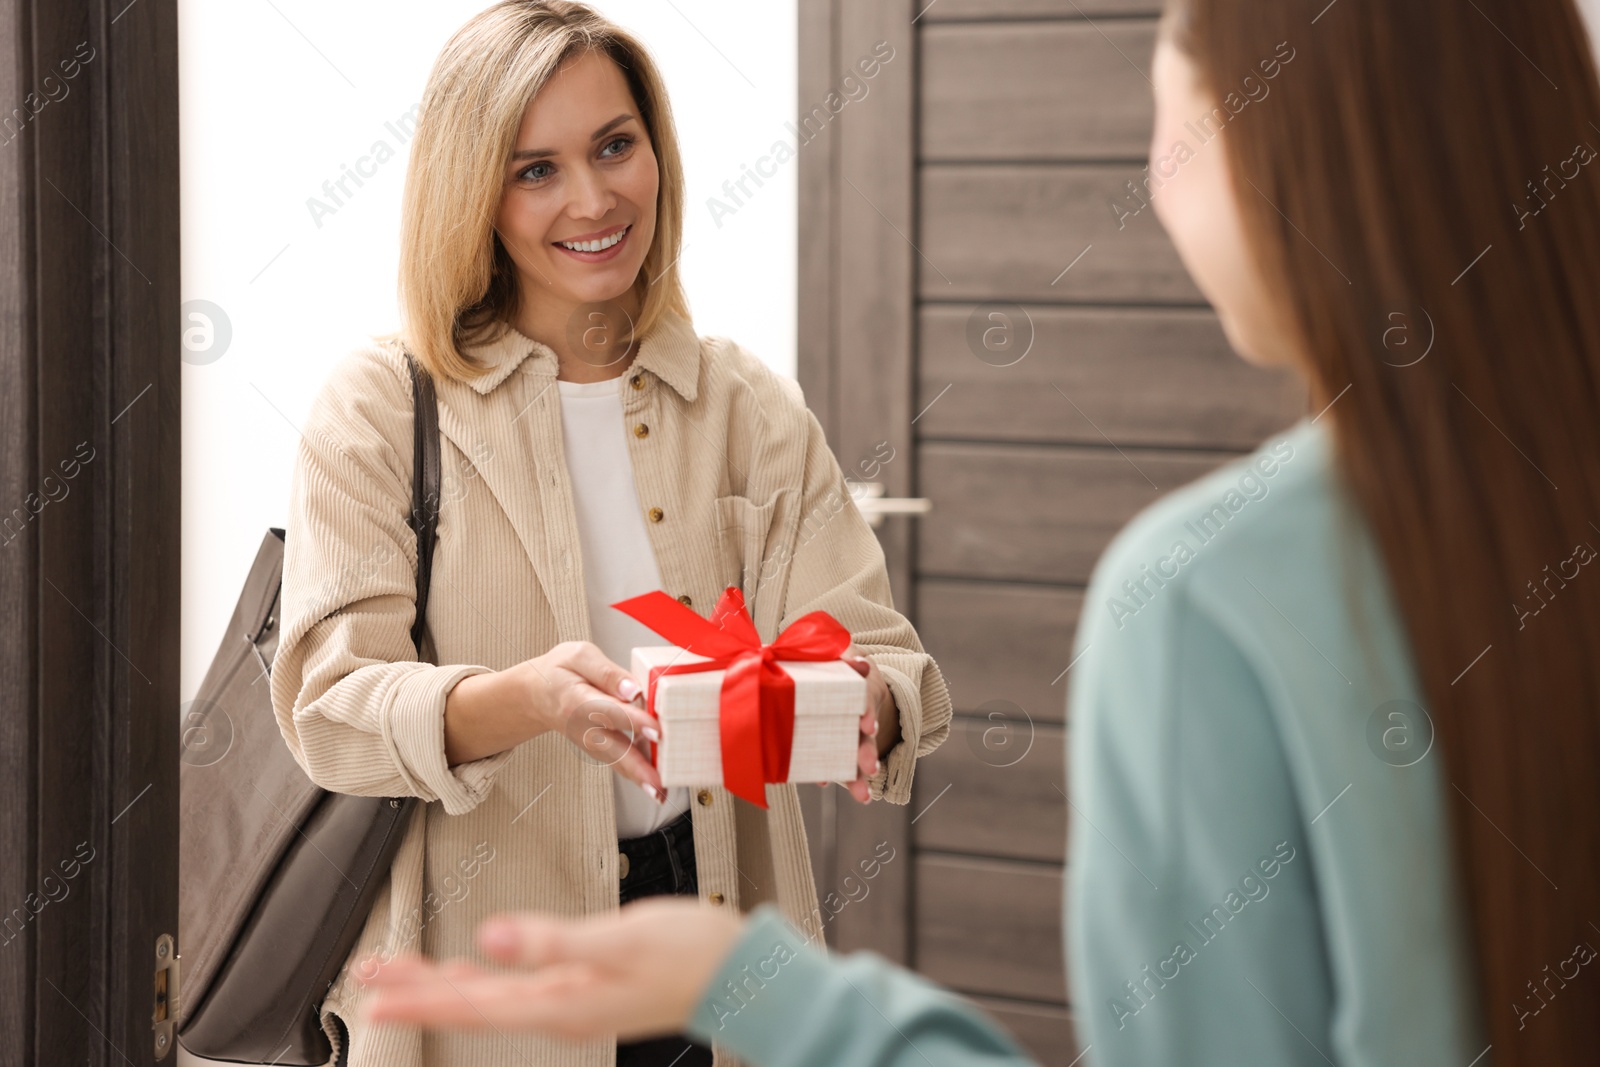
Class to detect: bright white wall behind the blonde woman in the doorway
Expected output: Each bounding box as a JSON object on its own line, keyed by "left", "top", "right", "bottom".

{"left": 179, "top": 0, "right": 797, "bottom": 701}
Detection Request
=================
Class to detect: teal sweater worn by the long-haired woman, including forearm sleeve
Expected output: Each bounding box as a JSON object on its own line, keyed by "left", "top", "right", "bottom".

{"left": 690, "top": 421, "right": 1484, "bottom": 1067}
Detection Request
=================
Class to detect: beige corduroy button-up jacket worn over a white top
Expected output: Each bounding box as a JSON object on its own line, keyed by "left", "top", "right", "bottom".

{"left": 272, "top": 303, "right": 950, "bottom": 1067}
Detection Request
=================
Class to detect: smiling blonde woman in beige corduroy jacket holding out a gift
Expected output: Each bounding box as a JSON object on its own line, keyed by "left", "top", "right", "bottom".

{"left": 272, "top": 0, "right": 950, "bottom": 1067}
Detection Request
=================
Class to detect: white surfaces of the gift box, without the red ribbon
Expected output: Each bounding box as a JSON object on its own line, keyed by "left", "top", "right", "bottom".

{"left": 632, "top": 645, "right": 867, "bottom": 785}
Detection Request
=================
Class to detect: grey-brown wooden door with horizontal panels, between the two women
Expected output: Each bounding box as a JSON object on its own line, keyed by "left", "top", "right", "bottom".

{"left": 797, "top": 0, "right": 1304, "bottom": 1062}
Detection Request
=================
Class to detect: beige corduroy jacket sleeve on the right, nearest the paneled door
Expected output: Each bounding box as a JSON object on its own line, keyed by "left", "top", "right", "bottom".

{"left": 779, "top": 410, "right": 952, "bottom": 805}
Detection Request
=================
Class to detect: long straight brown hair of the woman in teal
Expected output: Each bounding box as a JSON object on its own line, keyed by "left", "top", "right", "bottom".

{"left": 1163, "top": 0, "right": 1600, "bottom": 1067}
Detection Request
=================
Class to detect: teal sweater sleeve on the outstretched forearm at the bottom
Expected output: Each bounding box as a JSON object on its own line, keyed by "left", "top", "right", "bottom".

{"left": 688, "top": 904, "right": 1035, "bottom": 1067}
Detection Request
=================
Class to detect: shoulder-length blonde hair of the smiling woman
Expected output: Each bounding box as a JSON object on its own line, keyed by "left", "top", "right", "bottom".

{"left": 385, "top": 0, "right": 688, "bottom": 381}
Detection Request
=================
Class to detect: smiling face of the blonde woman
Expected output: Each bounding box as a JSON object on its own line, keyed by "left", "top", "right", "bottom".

{"left": 496, "top": 53, "right": 661, "bottom": 339}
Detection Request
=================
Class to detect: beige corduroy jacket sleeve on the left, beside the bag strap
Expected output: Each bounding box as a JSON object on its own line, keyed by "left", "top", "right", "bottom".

{"left": 270, "top": 349, "right": 512, "bottom": 814}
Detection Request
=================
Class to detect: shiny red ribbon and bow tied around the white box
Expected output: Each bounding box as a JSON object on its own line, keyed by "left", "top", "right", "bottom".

{"left": 611, "top": 585, "right": 850, "bottom": 808}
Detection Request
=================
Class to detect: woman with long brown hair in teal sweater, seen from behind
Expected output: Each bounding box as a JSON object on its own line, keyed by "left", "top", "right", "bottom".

{"left": 350, "top": 0, "right": 1600, "bottom": 1067}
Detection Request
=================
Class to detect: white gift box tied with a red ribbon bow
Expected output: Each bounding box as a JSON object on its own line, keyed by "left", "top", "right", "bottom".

{"left": 611, "top": 585, "right": 867, "bottom": 808}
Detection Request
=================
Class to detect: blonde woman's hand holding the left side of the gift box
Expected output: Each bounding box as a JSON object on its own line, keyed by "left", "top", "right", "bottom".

{"left": 522, "top": 641, "right": 667, "bottom": 801}
